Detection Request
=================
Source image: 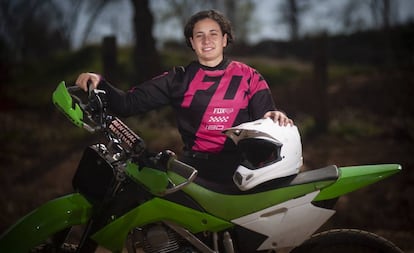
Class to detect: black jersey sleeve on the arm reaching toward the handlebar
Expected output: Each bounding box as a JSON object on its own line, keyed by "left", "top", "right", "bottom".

{"left": 99, "top": 68, "right": 176, "bottom": 117}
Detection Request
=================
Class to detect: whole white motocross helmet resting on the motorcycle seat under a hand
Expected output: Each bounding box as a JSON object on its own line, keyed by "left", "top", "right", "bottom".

{"left": 224, "top": 118, "right": 303, "bottom": 191}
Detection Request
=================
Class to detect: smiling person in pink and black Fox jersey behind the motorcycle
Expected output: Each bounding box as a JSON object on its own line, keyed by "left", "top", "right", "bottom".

{"left": 76, "top": 10, "right": 293, "bottom": 183}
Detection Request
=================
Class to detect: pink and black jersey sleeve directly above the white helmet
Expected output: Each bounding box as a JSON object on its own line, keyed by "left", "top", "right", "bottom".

{"left": 249, "top": 70, "right": 276, "bottom": 120}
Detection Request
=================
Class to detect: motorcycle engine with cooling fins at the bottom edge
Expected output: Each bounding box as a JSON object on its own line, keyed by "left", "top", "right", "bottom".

{"left": 134, "top": 224, "right": 193, "bottom": 253}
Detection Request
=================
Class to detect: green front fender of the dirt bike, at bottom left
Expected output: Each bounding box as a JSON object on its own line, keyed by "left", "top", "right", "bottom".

{"left": 0, "top": 193, "right": 92, "bottom": 252}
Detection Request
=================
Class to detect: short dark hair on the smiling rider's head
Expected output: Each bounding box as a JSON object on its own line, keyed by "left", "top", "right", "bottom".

{"left": 184, "top": 10, "right": 233, "bottom": 48}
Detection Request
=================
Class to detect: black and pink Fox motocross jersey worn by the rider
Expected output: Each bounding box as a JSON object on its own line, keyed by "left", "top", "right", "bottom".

{"left": 99, "top": 59, "right": 275, "bottom": 153}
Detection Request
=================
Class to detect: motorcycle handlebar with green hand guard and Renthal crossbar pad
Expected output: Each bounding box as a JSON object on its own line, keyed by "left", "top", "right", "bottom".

{"left": 53, "top": 82, "right": 198, "bottom": 195}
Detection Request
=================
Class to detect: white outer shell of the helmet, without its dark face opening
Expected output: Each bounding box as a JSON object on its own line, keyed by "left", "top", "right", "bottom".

{"left": 225, "top": 118, "right": 303, "bottom": 191}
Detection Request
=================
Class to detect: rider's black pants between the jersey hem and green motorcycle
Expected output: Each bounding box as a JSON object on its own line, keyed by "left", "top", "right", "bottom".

{"left": 180, "top": 151, "right": 240, "bottom": 183}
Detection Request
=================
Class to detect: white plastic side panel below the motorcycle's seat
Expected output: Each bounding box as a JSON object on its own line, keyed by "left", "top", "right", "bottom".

{"left": 232, "top": 191, "right": 335, "bottom": 250}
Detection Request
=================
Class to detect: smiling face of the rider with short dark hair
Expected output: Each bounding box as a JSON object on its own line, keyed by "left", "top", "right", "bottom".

{"left": 190, "top": 18, "right": 227, "bottom": 67}
